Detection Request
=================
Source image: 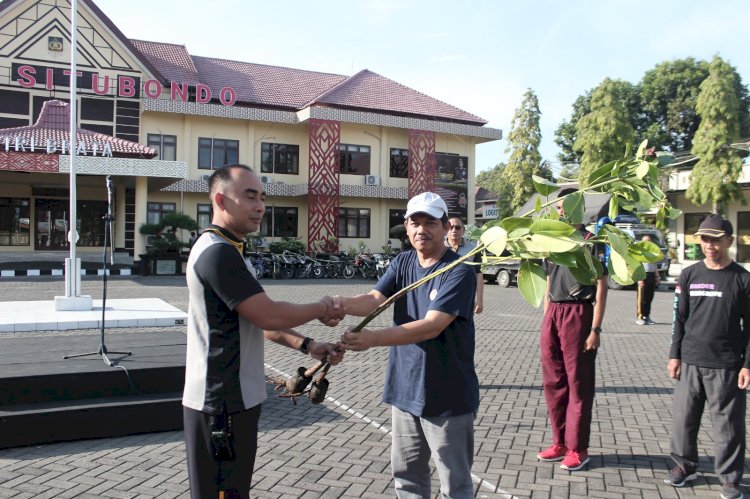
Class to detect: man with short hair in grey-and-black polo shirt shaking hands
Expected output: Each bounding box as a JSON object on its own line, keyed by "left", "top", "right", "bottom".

{"left": 187, "top": 165, "right": 343, "bottom": 499}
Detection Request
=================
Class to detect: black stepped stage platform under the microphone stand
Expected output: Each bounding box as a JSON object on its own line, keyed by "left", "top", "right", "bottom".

{"left": 0, "top": 328, "right": 186, "bottom": 448}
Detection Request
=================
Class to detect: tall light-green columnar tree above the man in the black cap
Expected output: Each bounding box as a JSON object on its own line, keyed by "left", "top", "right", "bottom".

{"left": 685, "top": 56, "right": 745, "bottom": 213}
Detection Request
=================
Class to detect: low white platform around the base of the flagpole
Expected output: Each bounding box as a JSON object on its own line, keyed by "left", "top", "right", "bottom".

{"left": 0, "top": 298, "right": 187, "bottom": 333}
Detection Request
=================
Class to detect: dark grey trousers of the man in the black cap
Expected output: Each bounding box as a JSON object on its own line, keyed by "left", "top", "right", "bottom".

{"left": 671, "top": 362, "right": 746, "bottom": 484}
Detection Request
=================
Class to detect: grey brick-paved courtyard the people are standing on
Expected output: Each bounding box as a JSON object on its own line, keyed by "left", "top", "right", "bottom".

{"left": 0, "top": 277, "right": 747, "bottom": 498}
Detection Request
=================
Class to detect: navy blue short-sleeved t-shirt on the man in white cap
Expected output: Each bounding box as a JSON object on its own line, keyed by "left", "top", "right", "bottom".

{"left": 375, "top": 249, "right": 479, "bottom": 417}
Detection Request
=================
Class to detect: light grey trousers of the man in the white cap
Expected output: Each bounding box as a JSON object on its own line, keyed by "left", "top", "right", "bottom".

{"left": 391, "top": 407, "right": 474, "bottom": 499}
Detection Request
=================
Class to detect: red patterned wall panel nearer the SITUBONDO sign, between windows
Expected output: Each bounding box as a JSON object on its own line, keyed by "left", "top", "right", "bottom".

{"left": 307, "top": 119, "right": 341, "bottom": 252}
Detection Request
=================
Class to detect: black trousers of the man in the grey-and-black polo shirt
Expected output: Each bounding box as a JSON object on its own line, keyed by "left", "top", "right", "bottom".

{"left": 182, "top": 404, "right": 261, "bottom": 499}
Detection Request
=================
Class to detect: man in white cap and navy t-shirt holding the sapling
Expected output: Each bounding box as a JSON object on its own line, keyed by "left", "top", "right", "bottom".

{"left": 334, "top": 192, "right": 479, "bottom": 499}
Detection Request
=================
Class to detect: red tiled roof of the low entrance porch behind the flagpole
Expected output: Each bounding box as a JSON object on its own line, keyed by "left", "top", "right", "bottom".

{"left": 0, "top": 100, "right": 157, "bottom": 158}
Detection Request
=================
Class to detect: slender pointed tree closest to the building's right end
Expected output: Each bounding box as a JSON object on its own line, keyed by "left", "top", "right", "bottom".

{"left": 503, "top": 88, "right": 551, "bottom": 211}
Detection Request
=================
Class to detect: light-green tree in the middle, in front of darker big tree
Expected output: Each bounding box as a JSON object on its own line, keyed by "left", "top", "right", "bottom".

{"left": 573, "top": 78, "right": 635, "bottom": 185}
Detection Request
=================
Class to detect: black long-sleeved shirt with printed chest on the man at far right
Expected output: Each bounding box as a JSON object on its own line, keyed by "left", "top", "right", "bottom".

{"left": 669, "top": 261, "right": 750, "bottom": 369}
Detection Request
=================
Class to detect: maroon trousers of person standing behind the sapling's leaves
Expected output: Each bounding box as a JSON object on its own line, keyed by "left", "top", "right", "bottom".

{"left": 541, "top": 302, "right": 596, "bottom": 451}
